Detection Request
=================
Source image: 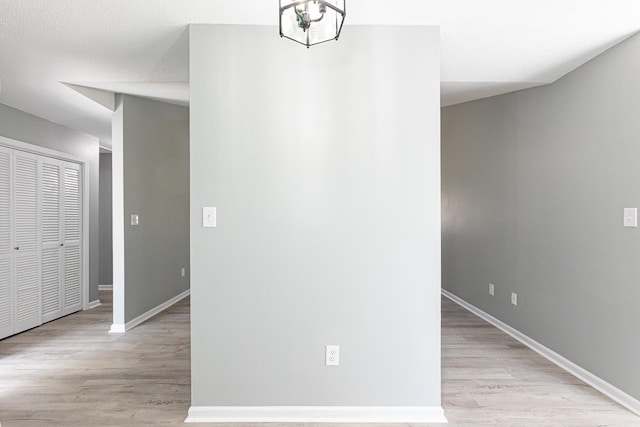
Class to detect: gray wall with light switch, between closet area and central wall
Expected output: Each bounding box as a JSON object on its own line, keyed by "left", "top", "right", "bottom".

{"left": 113, "top": 95, "right": 189, "bottom": 322}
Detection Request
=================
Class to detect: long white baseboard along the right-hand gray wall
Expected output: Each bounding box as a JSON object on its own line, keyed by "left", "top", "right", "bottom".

{"left": 442, "top": 289, "right": 640, "bottom": 415}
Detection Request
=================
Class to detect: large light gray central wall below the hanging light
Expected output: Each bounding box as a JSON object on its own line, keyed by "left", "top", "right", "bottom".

{"left": 190, "top": 25, "right": 440, "bottom": 406}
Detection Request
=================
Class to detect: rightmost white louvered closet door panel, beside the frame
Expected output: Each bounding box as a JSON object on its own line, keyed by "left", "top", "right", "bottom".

{"left": 62, "top": 162, "right": 82, "bottom": 315}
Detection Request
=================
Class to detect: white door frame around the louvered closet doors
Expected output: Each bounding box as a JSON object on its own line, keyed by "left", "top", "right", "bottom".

{"left": 0, "top": 136, "right": 90, "bottom": 310}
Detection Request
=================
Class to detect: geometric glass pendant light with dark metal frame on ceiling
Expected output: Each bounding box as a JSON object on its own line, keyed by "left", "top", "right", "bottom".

{"left": 280, "top": 0, "right": 346, "bottom": 47}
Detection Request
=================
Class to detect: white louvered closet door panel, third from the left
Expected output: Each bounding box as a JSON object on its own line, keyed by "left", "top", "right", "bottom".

{"left": 39, "top": 157, "right": 63, "bottom": 322}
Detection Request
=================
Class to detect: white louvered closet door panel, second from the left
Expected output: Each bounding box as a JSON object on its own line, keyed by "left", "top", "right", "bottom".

{"left": 13, "top": 151, "right": 42, "bottom": 333}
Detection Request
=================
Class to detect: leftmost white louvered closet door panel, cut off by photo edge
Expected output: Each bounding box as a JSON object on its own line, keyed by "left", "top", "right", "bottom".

{"left": 0, "top": 147, "right": 13, "bottom": 339}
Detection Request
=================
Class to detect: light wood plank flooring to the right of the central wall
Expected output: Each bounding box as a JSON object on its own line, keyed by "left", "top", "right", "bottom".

{"left": 442, "top": 298, "right": 640, "bottom": 427}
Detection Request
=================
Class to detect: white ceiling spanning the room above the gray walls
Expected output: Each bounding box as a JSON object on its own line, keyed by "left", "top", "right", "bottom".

{"left": 0, "top": 0, "right": 640, "bottom": 146}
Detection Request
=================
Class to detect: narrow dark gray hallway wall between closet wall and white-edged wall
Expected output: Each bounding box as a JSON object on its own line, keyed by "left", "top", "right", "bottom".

{"left": 98, "top": 153, "right": 113, "bottom": 285}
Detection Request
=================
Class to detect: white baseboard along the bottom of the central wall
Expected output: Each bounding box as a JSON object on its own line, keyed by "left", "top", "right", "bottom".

{"left": 185, "top": 406, "right": 447, "bottom": 423}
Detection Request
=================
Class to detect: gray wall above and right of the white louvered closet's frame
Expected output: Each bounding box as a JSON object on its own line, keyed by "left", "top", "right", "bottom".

{"left": 0, "top": 104, "right": 99, "bottom": 301}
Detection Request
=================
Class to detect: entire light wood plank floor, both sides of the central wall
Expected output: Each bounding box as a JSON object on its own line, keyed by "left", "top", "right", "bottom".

{"left": 0, "top": 292, "right": 640, "bottom": 427}
